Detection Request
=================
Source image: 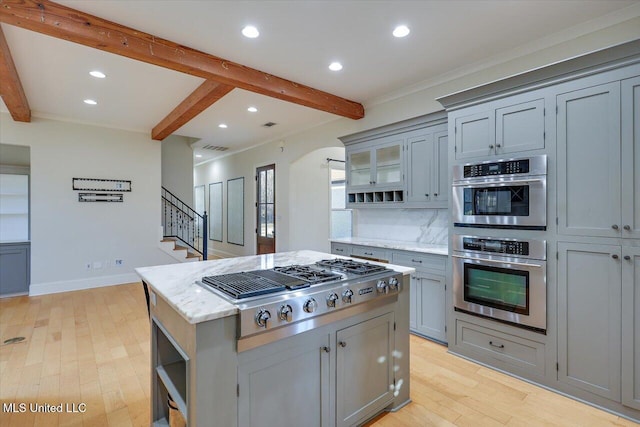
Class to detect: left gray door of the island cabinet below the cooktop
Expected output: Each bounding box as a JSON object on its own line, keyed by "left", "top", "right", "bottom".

{"left": 238, "top": 333, "right": 333, "bottom": 427}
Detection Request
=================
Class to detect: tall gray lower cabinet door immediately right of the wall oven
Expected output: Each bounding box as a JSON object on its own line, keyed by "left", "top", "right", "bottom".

{"left": 558, "top": 243, "right": 622, "bottom": 402}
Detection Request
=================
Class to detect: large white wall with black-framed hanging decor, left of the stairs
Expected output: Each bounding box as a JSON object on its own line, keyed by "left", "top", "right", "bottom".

{"left": 0, "top": 113, "right": 175, "bottom": 295}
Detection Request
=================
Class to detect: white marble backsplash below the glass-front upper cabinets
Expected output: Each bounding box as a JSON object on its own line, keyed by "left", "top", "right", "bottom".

{"left": 353, "top": 209, "right": 448, "bottom": 245}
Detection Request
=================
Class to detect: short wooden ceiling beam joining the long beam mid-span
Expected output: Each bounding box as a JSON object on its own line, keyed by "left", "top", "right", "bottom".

{"left": 151, "top": 80, "right": 233, "bottom": 141}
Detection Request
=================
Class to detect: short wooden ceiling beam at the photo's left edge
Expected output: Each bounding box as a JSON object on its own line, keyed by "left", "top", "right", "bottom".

{"left": 0, "top": 27, "right": 31, "bottom": 122}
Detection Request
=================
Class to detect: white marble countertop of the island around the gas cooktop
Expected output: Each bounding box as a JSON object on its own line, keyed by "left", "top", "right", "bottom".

{"left": 136, "top": 251, "right": 415, "bottom": 324}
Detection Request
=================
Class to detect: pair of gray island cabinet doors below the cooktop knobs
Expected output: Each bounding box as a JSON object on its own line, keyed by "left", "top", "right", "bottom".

{"left": 238, "top": 313, "right": 395, "bottom": 427}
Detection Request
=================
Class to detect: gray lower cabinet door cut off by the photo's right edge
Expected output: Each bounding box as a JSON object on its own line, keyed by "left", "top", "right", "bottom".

{"left": 622, "top": 248, "right": 640, "bottom": 410}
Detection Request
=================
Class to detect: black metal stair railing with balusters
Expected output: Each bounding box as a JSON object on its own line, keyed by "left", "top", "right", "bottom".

{"left": 162, "top": 187, "right": 208, "bottom": 261}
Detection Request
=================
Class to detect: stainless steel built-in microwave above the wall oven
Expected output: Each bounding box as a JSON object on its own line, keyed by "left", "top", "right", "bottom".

{"left": 453, "top": 155, "right": 547, "bottom": 230}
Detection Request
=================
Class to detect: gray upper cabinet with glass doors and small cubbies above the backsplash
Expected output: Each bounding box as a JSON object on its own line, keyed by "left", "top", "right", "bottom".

{"left": 340, "top": 112, "right": 449, "bottom": 208}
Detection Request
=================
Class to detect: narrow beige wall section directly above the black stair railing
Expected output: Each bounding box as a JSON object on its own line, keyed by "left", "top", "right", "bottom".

{"left": 162, "top": 135, "right": 195, "bottom": 208}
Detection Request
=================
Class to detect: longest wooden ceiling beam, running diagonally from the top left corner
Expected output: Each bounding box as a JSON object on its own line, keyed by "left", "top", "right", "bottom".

{"left": 0, "top": 0, "right": 364, "bottom": 119}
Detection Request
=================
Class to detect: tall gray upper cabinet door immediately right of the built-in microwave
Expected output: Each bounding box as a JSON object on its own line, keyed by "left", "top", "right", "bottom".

{"left": 557, "top": 82, "right": 621, "bottom": 237}
